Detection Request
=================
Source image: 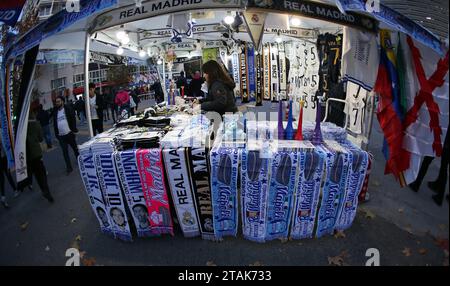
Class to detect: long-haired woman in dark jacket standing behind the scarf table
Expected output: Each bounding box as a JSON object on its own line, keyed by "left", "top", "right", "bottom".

{"left": 197, "top": 61, "right": 237, "bottom": 115}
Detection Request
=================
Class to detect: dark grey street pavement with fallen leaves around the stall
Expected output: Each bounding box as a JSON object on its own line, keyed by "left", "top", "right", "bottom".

{"left": 0, "top": 101, "right": 449, "bottom": 266}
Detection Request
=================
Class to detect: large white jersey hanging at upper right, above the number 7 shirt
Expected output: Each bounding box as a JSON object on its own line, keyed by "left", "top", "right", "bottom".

{"left": 341, "top": 27, "right": 380, "bottom": 91}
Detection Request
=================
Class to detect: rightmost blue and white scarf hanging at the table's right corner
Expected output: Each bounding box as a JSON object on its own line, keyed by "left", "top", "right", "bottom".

{"left": 335, "top": 143, "right": 369, "bottom": 230}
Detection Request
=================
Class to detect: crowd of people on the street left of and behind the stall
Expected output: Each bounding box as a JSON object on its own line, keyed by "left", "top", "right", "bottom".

{"left": 0, "top": 83, "right": 153, "bottom": 208}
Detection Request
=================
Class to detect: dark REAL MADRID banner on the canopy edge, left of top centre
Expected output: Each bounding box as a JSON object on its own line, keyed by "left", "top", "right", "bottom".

{"left": 90, "top": 0, "right": 242, "bottom": 31}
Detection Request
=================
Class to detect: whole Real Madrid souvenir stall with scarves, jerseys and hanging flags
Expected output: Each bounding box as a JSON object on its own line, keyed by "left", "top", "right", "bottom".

{"left": 0, "top": 0, "right": 448, "bottom": 242}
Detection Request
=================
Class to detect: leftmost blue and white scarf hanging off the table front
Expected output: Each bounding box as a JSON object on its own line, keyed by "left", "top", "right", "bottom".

{"left": 78, "top": 152, "right": 114, "bottom": 237}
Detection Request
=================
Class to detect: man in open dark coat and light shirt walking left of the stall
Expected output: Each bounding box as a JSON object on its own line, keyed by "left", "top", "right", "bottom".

{"left": 52, "top": 96, "right": 79, "bottom": 174}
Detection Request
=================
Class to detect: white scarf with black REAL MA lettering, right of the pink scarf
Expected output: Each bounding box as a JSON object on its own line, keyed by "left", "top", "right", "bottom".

{"left": 163, "top": 148, "right": 200, "bottom": 237}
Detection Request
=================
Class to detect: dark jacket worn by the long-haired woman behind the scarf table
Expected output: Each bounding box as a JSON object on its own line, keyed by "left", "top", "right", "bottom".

{"left": 202, "top": 80, "right": 237, "bottom": 115}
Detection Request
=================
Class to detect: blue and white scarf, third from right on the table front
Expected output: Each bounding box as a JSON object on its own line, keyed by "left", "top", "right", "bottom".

{"left": 291, "top": 141, "right": 326, "bottom": 239}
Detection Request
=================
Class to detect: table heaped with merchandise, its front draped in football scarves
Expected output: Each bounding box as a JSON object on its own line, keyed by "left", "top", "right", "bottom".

{"left": 79, "top": 104, "right": 369, "bottom": 242}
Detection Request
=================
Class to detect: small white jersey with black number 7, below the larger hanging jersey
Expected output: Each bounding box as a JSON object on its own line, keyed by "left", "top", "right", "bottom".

{"left": 345, "top": 82, "right": 369, "bottom": 134}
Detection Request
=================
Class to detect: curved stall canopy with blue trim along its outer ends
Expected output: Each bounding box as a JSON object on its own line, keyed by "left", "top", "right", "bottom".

{"left": 2, "top": 0, "right": 444, "bottom": 58}
